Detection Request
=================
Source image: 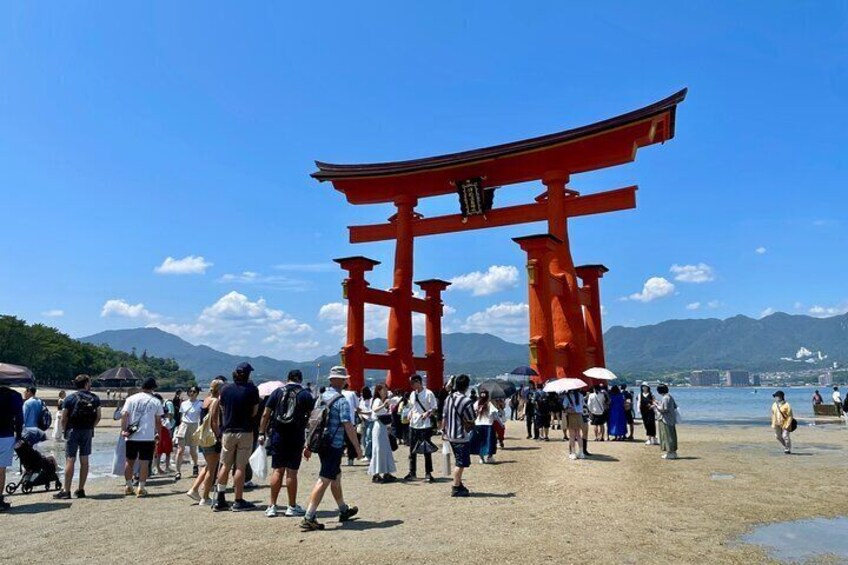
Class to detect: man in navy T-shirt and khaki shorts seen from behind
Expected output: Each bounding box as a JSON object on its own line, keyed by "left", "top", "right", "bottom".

{"left": 212, "top": 363, "right": 259, "bottom": 512}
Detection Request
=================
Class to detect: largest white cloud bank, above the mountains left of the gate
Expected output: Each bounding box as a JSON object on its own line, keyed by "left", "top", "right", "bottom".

{"left": 151, "top": 291, "right": 318, "bottom": 359}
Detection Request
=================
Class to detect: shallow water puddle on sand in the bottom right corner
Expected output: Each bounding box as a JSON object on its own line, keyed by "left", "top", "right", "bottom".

{"left": 740, "top": 516, "right": 848, "bottom": 562}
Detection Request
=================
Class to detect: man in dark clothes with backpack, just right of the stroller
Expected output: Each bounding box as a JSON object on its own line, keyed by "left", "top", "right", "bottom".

{"left": 53, "top": 375, "right": 100, "bottom": 500}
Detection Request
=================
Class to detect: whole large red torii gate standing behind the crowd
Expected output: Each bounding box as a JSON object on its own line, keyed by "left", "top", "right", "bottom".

{"left": 312, "top": 89, "right": 686, "bottom": 389}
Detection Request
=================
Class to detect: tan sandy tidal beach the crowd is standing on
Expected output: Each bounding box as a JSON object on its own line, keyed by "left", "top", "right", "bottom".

{"left": 0, "top": 422, "right": 848, "bottom": 564}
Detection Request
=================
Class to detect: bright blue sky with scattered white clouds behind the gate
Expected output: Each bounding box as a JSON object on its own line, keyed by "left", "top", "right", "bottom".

{"left": 0, "top": 2, "right": 848, "bottom": 359}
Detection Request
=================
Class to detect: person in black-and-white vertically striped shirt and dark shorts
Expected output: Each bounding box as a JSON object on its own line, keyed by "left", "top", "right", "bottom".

{"left": 442, "top": 375, "right": 476, "bottom": 497}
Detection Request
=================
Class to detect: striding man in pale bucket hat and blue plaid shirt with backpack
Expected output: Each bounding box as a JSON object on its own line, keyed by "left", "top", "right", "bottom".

{"left": 300, "top": 366, "right": 362, "bottom": 531}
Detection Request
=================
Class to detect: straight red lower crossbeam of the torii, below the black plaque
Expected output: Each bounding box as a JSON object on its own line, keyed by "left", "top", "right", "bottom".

{"left": 348, "top": 186, "right": 638, "bottom": 243}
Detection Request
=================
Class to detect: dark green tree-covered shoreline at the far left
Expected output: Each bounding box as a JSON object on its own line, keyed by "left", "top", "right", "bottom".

{"left": 0, "top": 315, "right": 195, "bottom": 388}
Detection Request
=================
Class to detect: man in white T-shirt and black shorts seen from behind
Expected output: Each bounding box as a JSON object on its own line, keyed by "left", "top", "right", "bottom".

{"left": 121, "top": 377, "right": 164, "bottom": 498}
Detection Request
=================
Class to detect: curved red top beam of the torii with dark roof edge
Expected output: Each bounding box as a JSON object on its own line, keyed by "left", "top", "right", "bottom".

{"left": 312, "top": 88, "right": 687, "bottom": 204}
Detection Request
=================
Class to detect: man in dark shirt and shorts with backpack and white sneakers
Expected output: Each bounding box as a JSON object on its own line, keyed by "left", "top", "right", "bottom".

{"left": 259, "top": 369, "right": 315, "bottom": 518}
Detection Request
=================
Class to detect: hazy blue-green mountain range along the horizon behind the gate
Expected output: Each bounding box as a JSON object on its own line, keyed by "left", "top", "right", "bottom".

{"left": 80, "top": 313, "right": 848, "bottom": 382}
